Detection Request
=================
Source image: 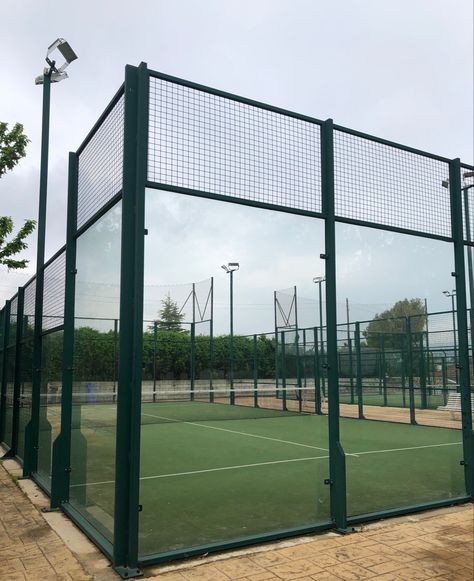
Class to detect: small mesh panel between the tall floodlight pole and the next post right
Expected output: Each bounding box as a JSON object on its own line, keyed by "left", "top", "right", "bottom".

{"left": 42, "top": 252, "right": 66, "bottom": 331}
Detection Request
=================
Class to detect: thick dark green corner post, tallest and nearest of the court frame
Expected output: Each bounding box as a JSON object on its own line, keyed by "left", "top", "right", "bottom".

{"left": 113, "top": 63, "right": 149, "bottom": 577}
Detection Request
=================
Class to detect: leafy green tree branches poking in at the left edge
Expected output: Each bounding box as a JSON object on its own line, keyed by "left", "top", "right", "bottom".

{"left": 0, "top": 121, "right": 36, "bottom": 269}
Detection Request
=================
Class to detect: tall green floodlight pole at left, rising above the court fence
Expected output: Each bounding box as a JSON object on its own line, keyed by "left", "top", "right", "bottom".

{"left": 23, "top": 38, "right": 77, "bottom": 476}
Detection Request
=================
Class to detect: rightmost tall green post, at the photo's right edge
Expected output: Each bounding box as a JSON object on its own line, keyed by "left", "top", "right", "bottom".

{"left": 449, "top": 159, "right": 474, "bottom": 498}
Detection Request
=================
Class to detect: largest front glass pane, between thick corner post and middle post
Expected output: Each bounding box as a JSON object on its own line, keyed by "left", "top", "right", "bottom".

{"left": 139, "top": 191, "right": 330, "bottom": 555}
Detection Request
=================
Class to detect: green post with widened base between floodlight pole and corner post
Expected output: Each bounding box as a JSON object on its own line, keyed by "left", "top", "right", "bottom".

{"left": 51, "top": 153, "right": 80, "bottom": 508}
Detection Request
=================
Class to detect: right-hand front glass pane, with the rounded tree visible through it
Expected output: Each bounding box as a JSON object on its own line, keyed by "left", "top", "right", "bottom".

{"left": 336, "top": 225, "right": 465, "bottom": 516}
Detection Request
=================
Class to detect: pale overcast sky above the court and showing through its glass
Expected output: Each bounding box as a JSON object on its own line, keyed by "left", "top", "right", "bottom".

{"left": 0, "top": 0, "right": 474, "bottom": 332}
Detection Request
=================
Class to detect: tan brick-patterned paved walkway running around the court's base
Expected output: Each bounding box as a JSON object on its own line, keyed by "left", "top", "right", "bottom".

{"left": 0, "top": 460, "right": 474, "bottom": 581}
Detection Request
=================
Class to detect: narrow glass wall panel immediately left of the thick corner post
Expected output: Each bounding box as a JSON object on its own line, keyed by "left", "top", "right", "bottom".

{"left": 70, "top": 202, "right": 121, "bottom": 541}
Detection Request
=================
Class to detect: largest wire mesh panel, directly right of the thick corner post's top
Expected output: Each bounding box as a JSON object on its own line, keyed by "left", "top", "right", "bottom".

{"left": 148, "top": 78, "right": 321, "bottom": 212}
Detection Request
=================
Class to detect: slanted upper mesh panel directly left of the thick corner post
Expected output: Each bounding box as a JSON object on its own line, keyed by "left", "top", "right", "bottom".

{"left": 77, "top": 96, "right": 124, "bottom": 228}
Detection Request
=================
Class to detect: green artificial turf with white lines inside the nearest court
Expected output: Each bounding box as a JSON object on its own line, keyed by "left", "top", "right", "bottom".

{"left": 66, "top": 402, "right": 465, "bottom": 555}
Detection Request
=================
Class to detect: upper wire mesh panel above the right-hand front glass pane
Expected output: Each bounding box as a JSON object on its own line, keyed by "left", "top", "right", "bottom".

{"left": 334, "top": 130, "right": 451, "bottom": 237}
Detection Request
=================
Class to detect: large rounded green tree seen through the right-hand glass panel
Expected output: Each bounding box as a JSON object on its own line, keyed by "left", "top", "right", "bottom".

{"left": 363, "top": 298, "right": 426, "bottom": 349}
